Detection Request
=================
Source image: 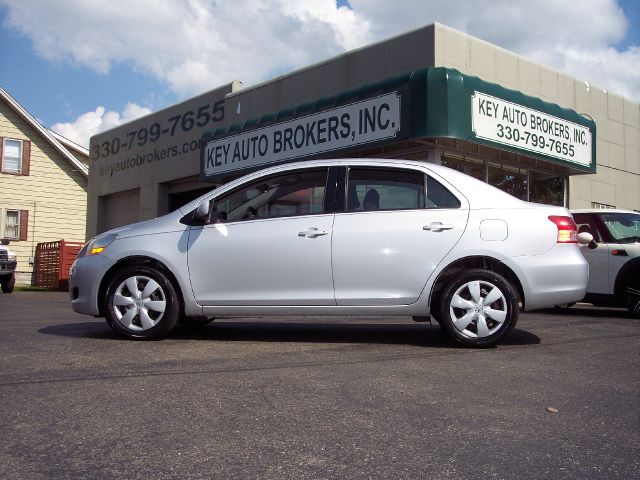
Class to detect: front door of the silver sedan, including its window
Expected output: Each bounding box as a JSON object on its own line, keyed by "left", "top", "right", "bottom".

{"left": 187, "top": 168, "right": 335, "bottom": 305}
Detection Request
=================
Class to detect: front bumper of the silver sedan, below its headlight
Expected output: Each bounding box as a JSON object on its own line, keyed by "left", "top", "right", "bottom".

{"left": 69, "top": 255, "right": 115, "bottom": 316}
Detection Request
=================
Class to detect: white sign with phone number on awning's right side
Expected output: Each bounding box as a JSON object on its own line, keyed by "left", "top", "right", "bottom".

{"left": 471, "top": 92, "right": 593, "bottom": 167}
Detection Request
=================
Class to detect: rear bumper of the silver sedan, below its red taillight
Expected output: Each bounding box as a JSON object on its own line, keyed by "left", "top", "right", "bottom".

{"left": 504, "top": 244, "right": 589, "bottom": 310}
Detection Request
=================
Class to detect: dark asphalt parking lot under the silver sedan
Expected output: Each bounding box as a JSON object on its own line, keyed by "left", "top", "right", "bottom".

{"left": 0, "top": 292, "right": 640, "bottom": 479}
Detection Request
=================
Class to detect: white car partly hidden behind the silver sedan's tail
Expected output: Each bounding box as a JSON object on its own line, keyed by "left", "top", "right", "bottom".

{"left": 572, "top": 209, "right": 640, "bottom": 318}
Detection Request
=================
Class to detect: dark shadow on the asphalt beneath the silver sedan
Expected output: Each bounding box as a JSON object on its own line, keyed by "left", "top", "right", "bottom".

{"left": 39, "top": 320, "right": 540, "bottom": 348}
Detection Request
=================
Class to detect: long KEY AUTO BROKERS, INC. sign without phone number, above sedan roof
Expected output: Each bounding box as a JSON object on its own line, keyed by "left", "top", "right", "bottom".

{"left": 202, "top": 92, "right": 400, "bottom": 177}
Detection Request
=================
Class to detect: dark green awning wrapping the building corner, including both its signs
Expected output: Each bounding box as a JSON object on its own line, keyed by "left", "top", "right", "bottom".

{"left": 201, "top": 67, "right": 596, "bottom": 180}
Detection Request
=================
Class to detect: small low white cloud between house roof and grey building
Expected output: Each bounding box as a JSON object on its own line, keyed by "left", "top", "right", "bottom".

{"left": 51, "top": 102, "right": 151, "bottom": 148}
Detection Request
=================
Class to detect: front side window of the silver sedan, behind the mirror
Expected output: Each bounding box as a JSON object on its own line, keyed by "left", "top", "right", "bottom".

{"left": 214, "top": 169, "right": 327, "bottom": 222}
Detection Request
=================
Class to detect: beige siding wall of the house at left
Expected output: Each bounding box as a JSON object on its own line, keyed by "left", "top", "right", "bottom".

{"left": 0, "top": 101, "right": 87, "bottom": 278}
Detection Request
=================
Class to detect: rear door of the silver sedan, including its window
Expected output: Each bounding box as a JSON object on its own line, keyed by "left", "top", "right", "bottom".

{"left": 332, "top": 167, "right": 468, "bottom": 305}
